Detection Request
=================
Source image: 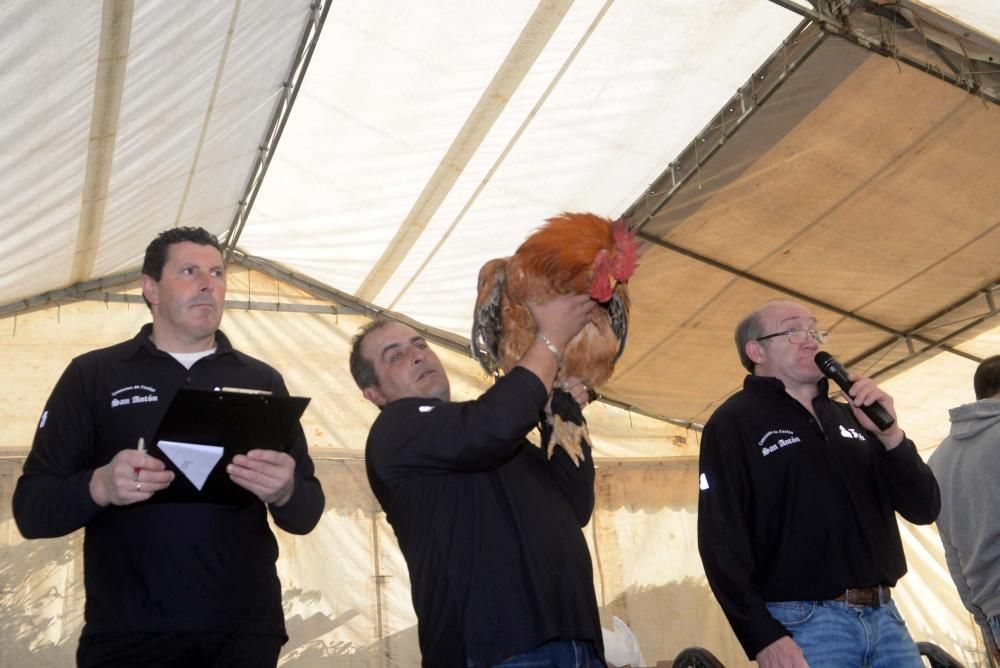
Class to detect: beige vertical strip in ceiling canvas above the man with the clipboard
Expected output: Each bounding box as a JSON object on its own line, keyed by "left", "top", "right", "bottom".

{"left": 70, "top": 0, "right": 134, "bottom": 283}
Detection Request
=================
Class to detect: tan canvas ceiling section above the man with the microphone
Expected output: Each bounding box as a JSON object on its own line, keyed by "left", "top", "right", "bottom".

{"left": 610, "top": 45, "right": 1000, "bottom": 421}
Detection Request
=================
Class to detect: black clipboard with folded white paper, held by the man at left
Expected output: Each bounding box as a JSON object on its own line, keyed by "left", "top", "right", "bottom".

{"left": 150, "top": 388, "right": 309, "bottom": 505}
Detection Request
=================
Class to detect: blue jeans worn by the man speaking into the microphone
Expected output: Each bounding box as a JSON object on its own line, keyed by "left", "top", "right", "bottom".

{"left": 767, "top": 601, "right": 924, "bottom": 668}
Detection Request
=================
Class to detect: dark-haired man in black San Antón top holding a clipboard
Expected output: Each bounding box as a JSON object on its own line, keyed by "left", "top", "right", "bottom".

{"left": 13, "top": 228, "right": 324, "bottom": 667}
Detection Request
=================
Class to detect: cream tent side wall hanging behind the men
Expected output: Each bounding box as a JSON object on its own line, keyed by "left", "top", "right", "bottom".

{"left": 0, "top": 288, "right": 980, "bottom": 667}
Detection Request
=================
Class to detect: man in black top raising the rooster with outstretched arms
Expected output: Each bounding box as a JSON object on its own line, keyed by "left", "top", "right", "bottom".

{"left": 351, "top": 295, "right": 605, "bottom": 667}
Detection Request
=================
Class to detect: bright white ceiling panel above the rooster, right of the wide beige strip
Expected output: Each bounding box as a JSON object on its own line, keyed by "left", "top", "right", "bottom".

{"left": 376, "top": 5, "right": 804, "bottom": 332}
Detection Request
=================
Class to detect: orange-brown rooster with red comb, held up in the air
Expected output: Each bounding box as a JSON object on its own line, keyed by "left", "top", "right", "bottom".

{"left": 472, "top": 213, "right": 638, "bottom": 466}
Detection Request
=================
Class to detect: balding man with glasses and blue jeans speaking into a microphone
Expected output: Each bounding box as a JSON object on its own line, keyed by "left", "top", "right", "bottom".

{"left": 698, "top": 301, "right": 941, "bottom": 668}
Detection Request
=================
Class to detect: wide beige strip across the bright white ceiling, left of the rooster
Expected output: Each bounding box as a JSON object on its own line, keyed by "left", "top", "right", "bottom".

{"left": 355, "top": 0, "right": 573, "bottom": 301}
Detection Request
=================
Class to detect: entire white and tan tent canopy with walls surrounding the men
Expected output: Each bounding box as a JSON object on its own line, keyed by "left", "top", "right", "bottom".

{"left": 0, "top": 0, "right": 1000, "bottom": 666}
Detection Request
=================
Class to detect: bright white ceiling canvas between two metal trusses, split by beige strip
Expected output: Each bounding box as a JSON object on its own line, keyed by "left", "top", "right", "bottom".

{"left": 242, "top": 3, "right": 797, "bottom": 334}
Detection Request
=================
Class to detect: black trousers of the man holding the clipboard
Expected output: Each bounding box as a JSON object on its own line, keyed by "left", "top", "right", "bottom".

{"left": 76, "top": 633, "right": 285, "bottom": 668}
